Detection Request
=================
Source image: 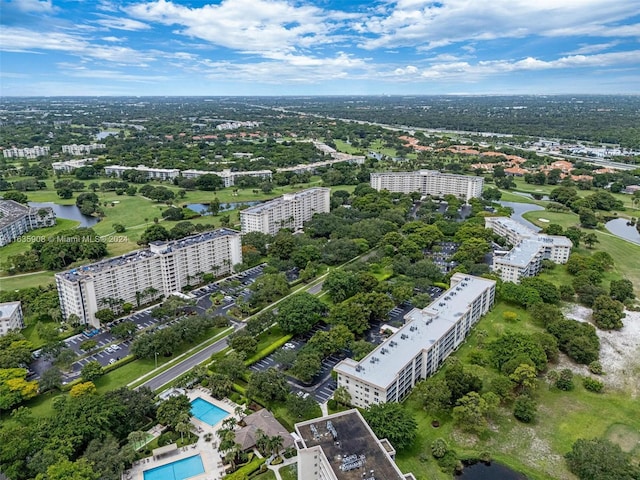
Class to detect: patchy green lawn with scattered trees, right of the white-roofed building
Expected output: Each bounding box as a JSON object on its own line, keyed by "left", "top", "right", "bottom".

{"left": 397, "top": 303, "right": 640, "bottom": 480}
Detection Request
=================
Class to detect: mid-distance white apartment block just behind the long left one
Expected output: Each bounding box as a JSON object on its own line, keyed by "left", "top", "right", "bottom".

{"left": 240, "top": 187, "right": 331, "bottom": 235}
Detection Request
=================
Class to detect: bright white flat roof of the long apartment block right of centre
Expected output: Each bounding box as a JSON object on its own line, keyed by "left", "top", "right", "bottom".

{"left": 335, "top": 275, "right": 495, "bottom": 388}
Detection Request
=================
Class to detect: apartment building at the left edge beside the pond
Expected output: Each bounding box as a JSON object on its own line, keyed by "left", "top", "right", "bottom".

{"left": 0, "top": 200, "right": 56, "bottom": 247}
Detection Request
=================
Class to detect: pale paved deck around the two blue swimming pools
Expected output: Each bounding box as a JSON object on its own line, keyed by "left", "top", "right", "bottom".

{"left": 122, "top": 387, "right": 237, "bottom": 480}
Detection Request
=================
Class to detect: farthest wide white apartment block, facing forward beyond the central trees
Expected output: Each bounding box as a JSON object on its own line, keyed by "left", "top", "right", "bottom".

{"left": 371, "top": 170, "right": 484, "bottom": 201}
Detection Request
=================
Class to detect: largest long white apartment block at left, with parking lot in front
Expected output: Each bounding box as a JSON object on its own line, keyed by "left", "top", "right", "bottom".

{"left": 55, "top": 228, "right": 242, "bottom": 327}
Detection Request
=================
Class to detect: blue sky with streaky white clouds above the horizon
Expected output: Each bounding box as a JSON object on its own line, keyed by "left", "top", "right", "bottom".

{"left": 0, "top": 0, "right": 640, "bottom": 96}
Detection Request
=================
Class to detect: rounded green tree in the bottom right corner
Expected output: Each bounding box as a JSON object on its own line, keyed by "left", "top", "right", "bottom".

{"left": 565, "top": 438, "right": 640, "bottom": 480}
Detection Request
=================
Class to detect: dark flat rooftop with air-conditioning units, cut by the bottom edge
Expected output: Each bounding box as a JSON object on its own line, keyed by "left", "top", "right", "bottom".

{"left": 296, "top": 410, "right": 406, "bottom": 480}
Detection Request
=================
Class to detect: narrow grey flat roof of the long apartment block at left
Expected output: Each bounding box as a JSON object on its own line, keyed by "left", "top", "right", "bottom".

{"left": 56, "top": 228, "right": 240, "bottom": 282}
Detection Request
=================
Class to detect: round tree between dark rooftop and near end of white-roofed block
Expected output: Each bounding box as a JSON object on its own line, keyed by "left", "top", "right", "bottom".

{"left": 362, "top": 402, "right": 418, "bottom": 451}
